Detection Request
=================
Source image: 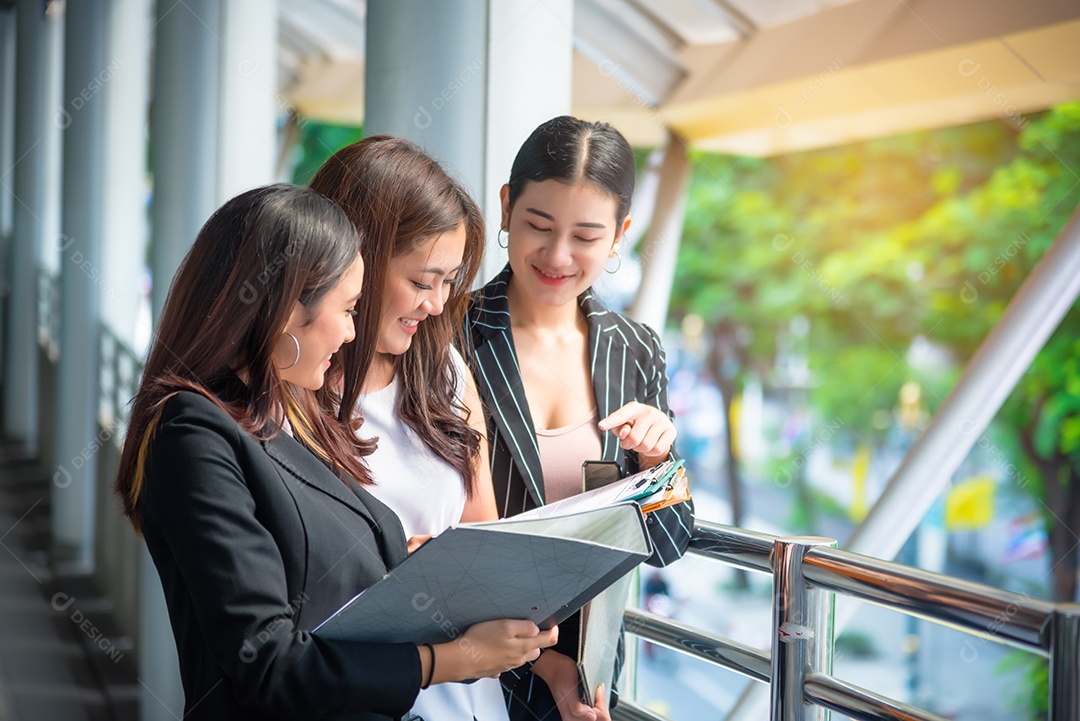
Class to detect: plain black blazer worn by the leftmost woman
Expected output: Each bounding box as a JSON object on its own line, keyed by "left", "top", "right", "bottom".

{"left": 139, "top": 393, "right": 421, "bottom": 721}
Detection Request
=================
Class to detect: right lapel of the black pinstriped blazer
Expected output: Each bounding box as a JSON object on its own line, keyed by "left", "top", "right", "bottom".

{"left": 579, "top": 288, "right": 626, "bottom": 461}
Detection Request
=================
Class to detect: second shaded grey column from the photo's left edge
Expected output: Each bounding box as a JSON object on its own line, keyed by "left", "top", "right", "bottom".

{"left": 51, "top": 0, "right": 106, "bottom": 572}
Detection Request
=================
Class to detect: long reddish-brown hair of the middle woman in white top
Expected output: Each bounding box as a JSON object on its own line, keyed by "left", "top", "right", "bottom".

{"left": 311, "top": 135, "right": 484, "bottom": 496}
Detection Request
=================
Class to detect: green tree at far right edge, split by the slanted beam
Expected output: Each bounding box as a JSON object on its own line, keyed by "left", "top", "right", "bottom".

{"left": 917, "top": 104, "right": 1080, "bottom": 601}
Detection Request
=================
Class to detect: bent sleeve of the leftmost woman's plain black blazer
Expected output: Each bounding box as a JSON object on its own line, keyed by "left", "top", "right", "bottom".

{"left": 140, "top": 402, "right": 420, "bottom": 719}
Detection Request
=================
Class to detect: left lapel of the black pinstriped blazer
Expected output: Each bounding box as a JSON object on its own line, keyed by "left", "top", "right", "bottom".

{"left": 473, "top": 266, "right": 545, "bottom": 505}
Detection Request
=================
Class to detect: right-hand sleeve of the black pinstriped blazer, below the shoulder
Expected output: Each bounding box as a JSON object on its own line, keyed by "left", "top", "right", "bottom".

{"left": 642, "top": 326, "right": 693, "bottom": 568}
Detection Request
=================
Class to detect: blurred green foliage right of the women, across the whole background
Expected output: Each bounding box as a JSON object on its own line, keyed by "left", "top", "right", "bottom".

{"left": 672, "top": 104, "right": 1080, "bottom": 600}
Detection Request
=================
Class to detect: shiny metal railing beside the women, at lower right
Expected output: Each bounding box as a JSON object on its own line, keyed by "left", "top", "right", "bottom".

{"left": 613, "top": 521, "right": 1080, "bottom": 721}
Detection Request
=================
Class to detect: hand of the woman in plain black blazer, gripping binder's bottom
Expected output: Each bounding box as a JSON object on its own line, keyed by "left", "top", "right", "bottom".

{"left": 420, "top": 620, "right": 558, "bottom": 683}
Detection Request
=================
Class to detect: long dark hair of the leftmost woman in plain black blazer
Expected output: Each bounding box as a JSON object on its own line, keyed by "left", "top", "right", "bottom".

{"left": 116, "top": 185, "right": 368, "bottom": 531}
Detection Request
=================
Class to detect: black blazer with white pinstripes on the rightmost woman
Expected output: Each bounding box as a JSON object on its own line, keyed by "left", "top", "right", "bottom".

{"left": 465, "top": 266, "right": 693, "bottom": 566}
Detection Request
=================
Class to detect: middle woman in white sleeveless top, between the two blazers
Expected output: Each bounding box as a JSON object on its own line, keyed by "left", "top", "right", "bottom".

{"left": 311, "top": 136, "right": 508, "bottom": 721}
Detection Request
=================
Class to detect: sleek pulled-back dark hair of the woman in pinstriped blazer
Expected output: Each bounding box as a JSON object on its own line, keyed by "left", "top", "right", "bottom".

{"left": 509, "top": 115, "right": 635, "bottom": 222}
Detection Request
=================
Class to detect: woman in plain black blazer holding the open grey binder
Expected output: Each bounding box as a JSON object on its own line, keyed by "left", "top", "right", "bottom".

{"left": 117, "top": 186, "right": 554, "bottom": 721}
